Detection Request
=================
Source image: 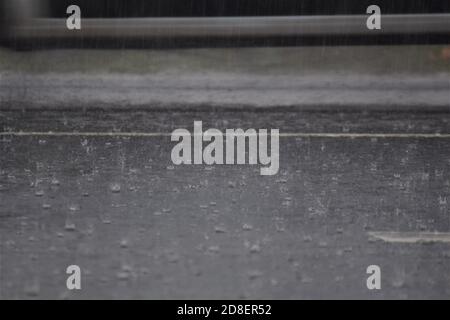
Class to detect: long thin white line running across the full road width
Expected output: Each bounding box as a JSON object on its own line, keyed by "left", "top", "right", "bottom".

{"left": 0, "top": 131, "right": 450, "bottom": 139}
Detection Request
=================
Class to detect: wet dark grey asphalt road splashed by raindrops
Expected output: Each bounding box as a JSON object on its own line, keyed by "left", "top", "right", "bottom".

{"left": 0, "top": 109, "right": 450, "bottom": 299}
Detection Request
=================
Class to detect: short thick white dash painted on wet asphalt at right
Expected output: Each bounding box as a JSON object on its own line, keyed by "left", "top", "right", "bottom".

{"left": 368, "top": 231, "right": 450, "bottom": 244}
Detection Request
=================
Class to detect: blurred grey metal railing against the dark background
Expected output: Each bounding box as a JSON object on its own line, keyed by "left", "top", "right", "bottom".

{"left": 8, "top": 14, "right": 450, "bottom": 39}
